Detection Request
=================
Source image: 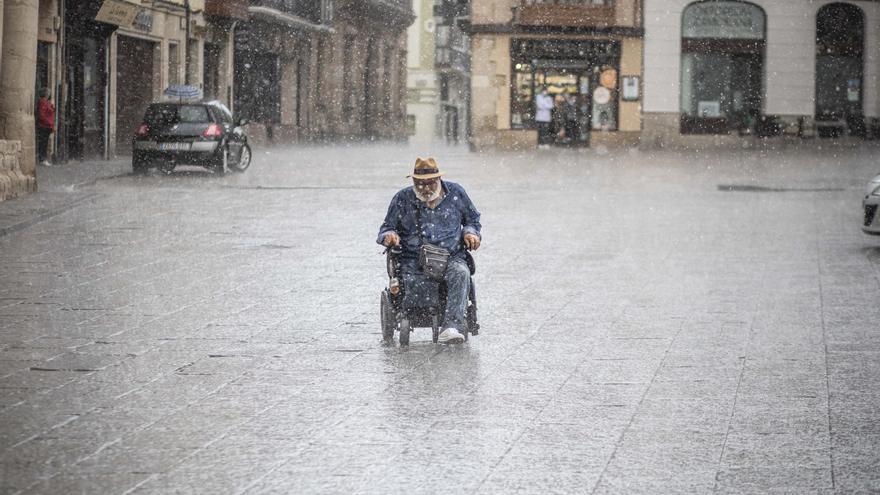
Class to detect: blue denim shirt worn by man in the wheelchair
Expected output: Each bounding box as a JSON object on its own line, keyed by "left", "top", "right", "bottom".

{"left": 376, "top": 181, "right": 482, "bottom": 270}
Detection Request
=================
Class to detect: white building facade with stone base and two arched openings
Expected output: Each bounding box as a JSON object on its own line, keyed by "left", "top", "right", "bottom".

{"left": 643, "top": 0, "right": 880, "bottom": 146}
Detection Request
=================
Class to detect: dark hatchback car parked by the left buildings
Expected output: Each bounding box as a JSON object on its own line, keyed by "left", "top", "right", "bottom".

{"left": 131, "top": 101, "right": 251, "bottom": 174}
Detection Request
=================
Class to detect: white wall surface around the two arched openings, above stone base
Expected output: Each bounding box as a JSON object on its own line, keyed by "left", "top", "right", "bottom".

{"left": 644, "top": 0, "right": 880, "bottom": 116}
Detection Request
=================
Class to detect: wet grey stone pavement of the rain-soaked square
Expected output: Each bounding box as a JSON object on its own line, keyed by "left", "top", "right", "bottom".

{"left": 0, "top": 142, "right": 880, "bottom": 494}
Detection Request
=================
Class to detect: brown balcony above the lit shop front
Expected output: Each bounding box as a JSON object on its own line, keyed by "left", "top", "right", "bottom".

{"left": 516, "top": 0, "right": 615, "bottom": 27}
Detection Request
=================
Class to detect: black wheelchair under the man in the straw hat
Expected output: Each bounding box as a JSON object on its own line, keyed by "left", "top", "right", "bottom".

{"left": 379, "top": 247, "right": 480, "bottom": 346}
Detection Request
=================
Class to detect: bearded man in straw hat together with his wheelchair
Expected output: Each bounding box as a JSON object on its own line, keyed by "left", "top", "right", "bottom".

{"left": 377, "top": 158, "right": 482, "bottom": 345}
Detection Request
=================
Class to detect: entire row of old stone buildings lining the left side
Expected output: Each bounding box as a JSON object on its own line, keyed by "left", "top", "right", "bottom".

{"left": 0, "top": 0, "right": 415, "bottom": 199}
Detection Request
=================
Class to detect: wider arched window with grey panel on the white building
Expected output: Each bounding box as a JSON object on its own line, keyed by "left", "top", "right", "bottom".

{"left": 681, "top": 0, "right": 766, "bottom": 134}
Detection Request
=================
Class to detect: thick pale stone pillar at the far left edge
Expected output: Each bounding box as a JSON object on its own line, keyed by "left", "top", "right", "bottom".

{"left": 0, "top": 0, "right": 39, "bottom": 196}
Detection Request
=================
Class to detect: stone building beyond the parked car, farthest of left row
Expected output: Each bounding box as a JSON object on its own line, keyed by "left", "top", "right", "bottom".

{"left": 235, "top": 0, "right": 415, "bottom": 143}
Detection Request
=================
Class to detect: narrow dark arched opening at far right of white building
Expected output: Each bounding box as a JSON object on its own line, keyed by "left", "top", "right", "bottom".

{"left": 816, "top": 3, "right": 865, "bottom": 136}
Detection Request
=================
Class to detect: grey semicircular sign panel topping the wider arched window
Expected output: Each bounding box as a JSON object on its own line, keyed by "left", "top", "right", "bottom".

{"left": 682, "top": 2, "right": 764, "bottom": 39}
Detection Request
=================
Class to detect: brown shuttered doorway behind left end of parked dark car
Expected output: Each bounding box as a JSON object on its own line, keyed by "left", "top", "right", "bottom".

{"left": 116, "top": 36, "right": 156, "bottom": 155}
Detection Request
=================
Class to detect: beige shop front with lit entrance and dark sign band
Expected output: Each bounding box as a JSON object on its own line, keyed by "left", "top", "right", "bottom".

{"left": 470, "top": 28, "right": 642, "bottom": 149}
